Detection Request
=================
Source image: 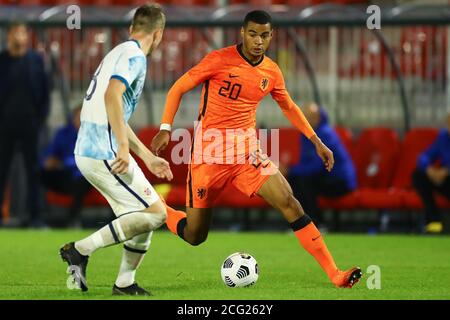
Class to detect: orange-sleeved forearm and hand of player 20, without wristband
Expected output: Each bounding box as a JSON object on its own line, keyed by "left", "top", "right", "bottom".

{"left": 278, "top": 95, "right": 334, "bottom": 172}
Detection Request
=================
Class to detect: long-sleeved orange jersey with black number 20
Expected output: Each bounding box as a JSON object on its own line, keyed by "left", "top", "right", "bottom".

{"left": 162, "top": 45, "right": 314, "bottom": 163}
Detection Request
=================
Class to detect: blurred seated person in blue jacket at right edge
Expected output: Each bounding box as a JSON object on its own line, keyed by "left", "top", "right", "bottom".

{"left": 413, "top": 112, "right": 450, "bottom": 233}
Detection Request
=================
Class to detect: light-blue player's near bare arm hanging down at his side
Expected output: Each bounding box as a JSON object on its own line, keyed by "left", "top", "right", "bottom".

{"left": 105, "top": 79, "right": 130, "bottom": 174}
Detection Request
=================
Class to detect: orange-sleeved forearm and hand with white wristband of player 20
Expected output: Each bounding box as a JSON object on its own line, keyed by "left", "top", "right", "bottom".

{"left": 151, "top": 73, "right": 198, "bottom": 154}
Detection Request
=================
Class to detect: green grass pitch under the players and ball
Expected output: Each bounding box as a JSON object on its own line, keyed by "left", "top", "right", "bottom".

{"left": 0, "top": 230, "right": 450, "bottom": 300}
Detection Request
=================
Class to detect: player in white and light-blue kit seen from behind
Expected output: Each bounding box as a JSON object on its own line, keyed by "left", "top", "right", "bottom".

{"left": 60, "top": 4, "right": 173, "bottom": 295}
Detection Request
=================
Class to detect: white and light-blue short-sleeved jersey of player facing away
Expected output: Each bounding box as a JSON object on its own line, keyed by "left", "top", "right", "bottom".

{"left": 75, "top": 40, "right": 147, "bottom": 160}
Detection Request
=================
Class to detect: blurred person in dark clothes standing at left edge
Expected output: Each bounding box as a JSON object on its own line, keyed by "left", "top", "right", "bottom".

{"left": 0, "top": 22, "right": 49, "bottom": 227}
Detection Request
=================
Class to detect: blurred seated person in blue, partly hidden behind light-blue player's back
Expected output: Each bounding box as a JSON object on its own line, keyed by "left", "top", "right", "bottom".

{"left": 41, "top": 106, "right": 91, "bottom": 226}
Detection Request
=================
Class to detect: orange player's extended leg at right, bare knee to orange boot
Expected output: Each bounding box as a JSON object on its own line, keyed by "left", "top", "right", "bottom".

{"left": 256, "top": 171, "right": 362, "bottom": 288}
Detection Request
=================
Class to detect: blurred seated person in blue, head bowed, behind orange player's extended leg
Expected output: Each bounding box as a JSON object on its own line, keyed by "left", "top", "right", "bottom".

{"left": 288, "top": 103, "right": 356, "bottom": 227}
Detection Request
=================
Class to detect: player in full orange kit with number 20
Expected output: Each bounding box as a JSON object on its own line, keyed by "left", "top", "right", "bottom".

{"left": 151, "top": 10, "right": 362, "bottom": 288}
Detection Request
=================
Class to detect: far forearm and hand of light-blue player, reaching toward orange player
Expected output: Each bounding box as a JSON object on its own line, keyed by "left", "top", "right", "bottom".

{"left": 127, "top": 125, "right": 173, "bottom": 181}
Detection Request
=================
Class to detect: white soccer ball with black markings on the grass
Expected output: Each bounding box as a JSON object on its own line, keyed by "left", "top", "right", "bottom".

{"left": 220, "top": 252, "right": 259, "bottom": 287}
